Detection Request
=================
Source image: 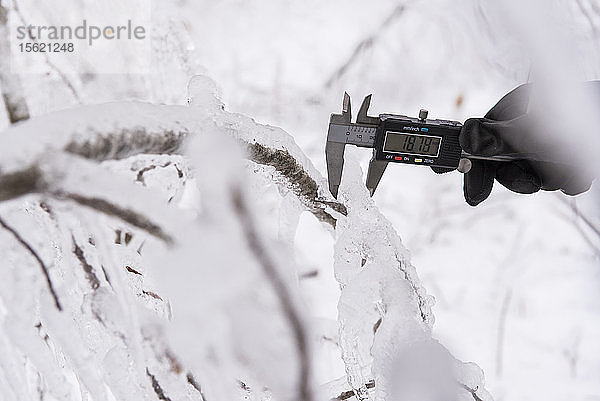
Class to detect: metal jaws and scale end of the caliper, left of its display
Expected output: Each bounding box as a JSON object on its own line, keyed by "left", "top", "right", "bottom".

{"left": 325, "top": 92, "right": 388, "bottom": 198}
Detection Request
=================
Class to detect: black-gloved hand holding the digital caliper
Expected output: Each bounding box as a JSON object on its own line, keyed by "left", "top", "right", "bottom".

{"left": 459, "top": 84, "right": 592, "bottom": 206}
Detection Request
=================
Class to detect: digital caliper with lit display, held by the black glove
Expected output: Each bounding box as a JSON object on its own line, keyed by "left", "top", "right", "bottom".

{"left": 325, "top": 93, "right": 523, "bottom": 198}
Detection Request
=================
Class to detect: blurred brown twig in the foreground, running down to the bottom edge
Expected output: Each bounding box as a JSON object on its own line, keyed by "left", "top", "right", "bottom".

{"left": 231, "top": 188, "right": 313, "bottom": 401}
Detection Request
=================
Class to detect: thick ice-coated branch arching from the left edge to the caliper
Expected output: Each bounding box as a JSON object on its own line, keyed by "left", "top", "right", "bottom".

{"left": 0, "top": 102, "right": 345, "bottom": 226}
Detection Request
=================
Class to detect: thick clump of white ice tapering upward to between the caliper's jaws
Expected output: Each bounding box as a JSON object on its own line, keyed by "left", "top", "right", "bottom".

{"left": 334, "top": 160, "right": 488, "bottom": 401}
